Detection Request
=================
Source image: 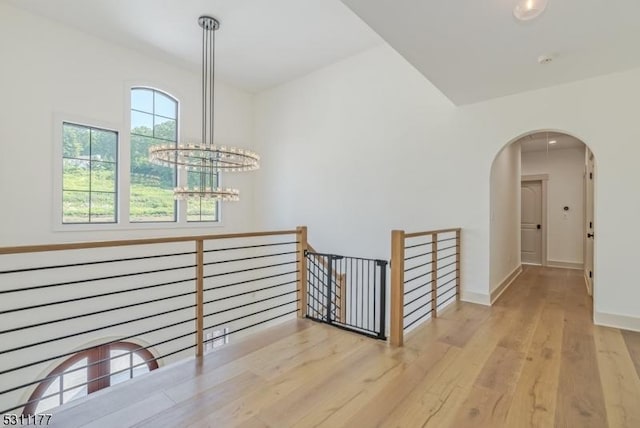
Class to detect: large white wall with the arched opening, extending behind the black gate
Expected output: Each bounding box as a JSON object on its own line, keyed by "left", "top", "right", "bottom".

{"left": 254, "top": 46, "right": 640, "bottom": 328}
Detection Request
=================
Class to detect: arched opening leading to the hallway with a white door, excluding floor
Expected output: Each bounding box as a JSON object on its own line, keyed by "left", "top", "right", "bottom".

{"left": 490, "top": 130, "right": 596, "bottom": 302}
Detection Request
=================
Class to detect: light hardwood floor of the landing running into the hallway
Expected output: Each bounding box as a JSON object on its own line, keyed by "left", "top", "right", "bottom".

{"left": 52, "top": 267, "right": 640, "bottom": 428}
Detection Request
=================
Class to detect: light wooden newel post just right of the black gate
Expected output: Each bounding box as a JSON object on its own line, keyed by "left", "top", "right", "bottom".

{"left": 390, "top": 230, "right": 404, "bottom": 346}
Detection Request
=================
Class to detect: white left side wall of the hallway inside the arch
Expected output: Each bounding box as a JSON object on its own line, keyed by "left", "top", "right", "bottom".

{"left": 489, "top": 143, "right": 521, "bottom": 291}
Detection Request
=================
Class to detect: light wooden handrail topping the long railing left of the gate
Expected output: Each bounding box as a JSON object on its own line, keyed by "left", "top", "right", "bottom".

{"left": 0, "top": 229, "right": 298, "bottom": 255}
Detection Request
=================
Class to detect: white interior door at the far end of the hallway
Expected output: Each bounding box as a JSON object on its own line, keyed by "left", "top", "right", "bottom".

{"left": 520, "top": 181, "right": 542, "bottom": 265}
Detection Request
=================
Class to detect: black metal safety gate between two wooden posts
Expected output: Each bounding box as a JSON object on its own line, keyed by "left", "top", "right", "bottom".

{"left": 306, "top": 251, "right": 387, "bottom": 340}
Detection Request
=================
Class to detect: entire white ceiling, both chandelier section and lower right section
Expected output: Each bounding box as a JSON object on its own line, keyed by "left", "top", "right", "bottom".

{"left": 8, "top": 0, "right": 640, "bottom": 105}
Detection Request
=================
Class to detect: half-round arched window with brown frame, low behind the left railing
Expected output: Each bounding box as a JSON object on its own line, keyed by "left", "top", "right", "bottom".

{"left": 23, "top": 342, "right": 158, "bottom": 414}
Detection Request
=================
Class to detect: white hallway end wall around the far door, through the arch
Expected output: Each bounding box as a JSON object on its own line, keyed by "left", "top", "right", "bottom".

{"left": 522, "top": 147, "right": 585, "bottom": 265}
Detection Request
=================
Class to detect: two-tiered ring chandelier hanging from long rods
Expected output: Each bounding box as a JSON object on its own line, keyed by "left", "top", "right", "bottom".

{"left": 149, "top": 16, "right": 260, "bottom": 201}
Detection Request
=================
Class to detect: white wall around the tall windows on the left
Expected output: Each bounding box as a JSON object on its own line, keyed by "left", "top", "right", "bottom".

{"left": 0, "top": 3, "right": 253, "bottom": 245}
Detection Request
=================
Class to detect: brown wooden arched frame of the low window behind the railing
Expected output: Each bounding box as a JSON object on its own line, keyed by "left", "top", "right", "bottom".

{"left": 22, "top": 342, "right": 160, "bottom": 415}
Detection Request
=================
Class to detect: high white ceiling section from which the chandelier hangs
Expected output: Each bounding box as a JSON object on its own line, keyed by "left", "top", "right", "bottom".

{"left": 4, "top": 0, "right": 384, "bottom": 91}
